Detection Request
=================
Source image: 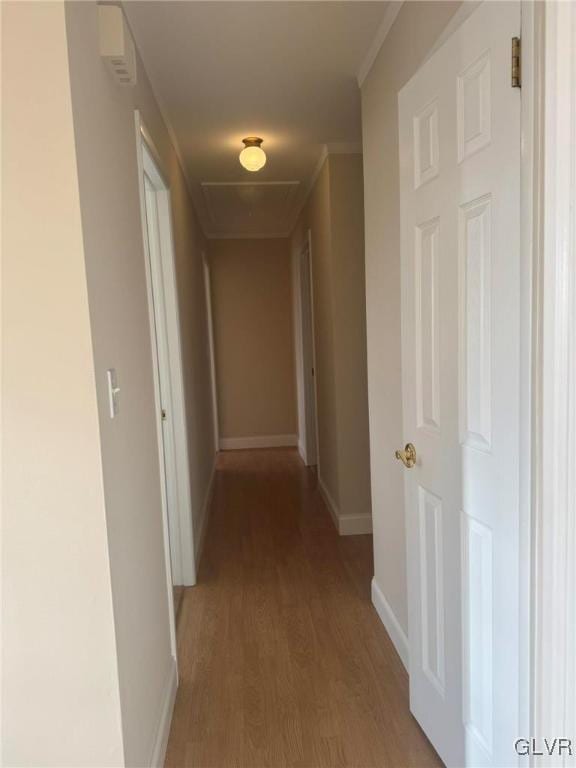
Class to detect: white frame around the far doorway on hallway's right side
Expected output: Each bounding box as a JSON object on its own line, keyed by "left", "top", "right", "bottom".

{"left": 296, "top": 229, "right": 320, "bottom": 474}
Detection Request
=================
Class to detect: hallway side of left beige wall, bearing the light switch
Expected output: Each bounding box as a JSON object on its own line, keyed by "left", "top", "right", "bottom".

{"left": 66, "top": 2, "right": 215, "bottom": 765}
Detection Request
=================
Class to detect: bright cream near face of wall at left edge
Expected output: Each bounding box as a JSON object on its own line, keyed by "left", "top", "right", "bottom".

{"left": 0, "top": 3, "right": 123, "bottom": 768}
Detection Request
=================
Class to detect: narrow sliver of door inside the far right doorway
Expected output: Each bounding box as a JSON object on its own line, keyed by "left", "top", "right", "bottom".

{"left": 300, "top": 245, "right": 318, "bottom": 467}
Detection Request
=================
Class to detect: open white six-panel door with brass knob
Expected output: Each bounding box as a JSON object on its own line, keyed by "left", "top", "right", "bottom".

{"left": 399, "top": 2, "right": 520, "bottom": 766}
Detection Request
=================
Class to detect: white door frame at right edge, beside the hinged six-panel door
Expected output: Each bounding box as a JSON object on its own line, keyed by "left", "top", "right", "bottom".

{"left": 525, "top": 2, "right": 576, "bottom": 756}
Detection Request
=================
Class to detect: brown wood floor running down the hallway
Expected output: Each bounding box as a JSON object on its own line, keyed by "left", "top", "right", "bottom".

{"left": 166, "top": 449, "right": 441, "bottom": 768}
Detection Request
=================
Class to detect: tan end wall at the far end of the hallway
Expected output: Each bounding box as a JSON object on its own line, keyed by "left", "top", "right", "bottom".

{"left": 209, "top": 239, "right": 297, "bottom": 438}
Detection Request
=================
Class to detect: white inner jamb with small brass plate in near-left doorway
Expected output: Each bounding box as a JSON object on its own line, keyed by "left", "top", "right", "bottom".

{"left": 144, "top": 164, "right": 184, "bottom": 584}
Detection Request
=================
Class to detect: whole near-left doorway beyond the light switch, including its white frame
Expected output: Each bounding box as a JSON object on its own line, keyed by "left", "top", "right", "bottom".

{"left": 136, "top": 115, "right": 196, "bottom": 613}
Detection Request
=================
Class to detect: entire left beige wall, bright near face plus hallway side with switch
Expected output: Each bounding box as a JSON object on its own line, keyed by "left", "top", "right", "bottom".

{"left": 2, "top": 2, "right": 215, "bottom": 766}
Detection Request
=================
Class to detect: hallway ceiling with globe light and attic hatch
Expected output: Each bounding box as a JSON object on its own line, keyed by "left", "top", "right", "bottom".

{"left": 123, "top": 0, "right": 389, "bottom": 237}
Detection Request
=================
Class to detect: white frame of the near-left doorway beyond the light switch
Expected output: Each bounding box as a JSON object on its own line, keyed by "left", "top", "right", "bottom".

{"left": 135, "top": 110, "right": 196, "bottom": 596}
